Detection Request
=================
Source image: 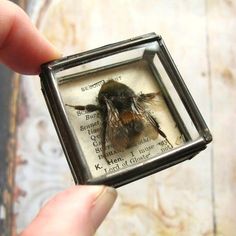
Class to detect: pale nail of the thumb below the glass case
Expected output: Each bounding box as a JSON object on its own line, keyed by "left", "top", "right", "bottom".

{"left": 91, "top": 186, "right": 117, "bottom": 230}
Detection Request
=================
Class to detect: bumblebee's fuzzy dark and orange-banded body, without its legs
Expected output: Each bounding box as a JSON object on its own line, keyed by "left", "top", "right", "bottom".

{"left": 98, "top": 80, "right": 144, "bottom": 151}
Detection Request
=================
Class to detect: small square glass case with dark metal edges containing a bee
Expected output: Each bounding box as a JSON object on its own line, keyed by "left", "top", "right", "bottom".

{"left": 40, "top": 33, "right": 212, "bottom": 187}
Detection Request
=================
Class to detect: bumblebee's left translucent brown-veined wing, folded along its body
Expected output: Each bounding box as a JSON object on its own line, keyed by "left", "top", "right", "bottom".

{"left": 105, "top": 99, "right": 129, "bottom": 151}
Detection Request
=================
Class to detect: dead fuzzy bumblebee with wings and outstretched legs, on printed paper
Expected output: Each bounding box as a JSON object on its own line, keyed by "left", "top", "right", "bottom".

{"left": 66, "top": 80, "right": 173, "bottom": 160}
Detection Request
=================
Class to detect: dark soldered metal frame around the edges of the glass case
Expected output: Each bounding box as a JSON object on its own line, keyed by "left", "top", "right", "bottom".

{"left": 40, "top": 33, "right": 212, "bottom": 187}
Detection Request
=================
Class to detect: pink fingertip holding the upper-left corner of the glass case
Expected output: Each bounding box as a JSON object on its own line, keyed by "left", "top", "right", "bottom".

{"left": 0, "top": 0, "right": 60, "bottom": 74}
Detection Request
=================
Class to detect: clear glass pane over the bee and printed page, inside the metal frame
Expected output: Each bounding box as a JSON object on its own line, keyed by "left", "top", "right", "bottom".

{"left": 55, "top": 43, "right": 186, "bottom": 178}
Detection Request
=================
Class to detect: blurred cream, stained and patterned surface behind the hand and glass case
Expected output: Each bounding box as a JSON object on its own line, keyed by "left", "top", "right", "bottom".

{"left": 0, "top": 0, "right": 236, "bottom": 236}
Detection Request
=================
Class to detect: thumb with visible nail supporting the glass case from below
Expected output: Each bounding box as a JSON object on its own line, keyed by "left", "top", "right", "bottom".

{"left": 20, "top": 186, "right": 117, "bottom": 236}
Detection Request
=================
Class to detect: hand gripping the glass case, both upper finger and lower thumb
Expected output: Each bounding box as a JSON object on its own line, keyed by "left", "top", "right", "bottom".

{"left": 0, "top": 0, "right": 117, "bottom": 236}
